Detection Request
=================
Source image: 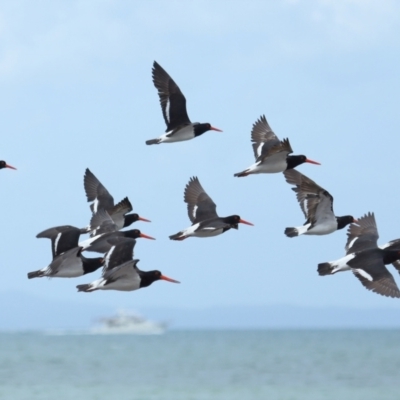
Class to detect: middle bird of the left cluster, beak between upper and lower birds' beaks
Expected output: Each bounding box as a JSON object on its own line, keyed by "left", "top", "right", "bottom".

{"left": 79, "top": 209, "right": 155, "bottom": 253}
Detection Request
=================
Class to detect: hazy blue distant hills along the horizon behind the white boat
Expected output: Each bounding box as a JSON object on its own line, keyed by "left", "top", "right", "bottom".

{"left": 0, "top": 293, "right": 400, "bottom": 331}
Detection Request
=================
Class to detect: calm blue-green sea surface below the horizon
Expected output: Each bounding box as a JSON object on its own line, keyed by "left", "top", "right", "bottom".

{"left": 0, "top": 330, "right": 400, "bottom": 400}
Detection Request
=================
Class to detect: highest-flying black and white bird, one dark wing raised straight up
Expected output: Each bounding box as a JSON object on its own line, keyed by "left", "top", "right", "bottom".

{"left": 146, "top": 61, "right": 222, "bottom": 144}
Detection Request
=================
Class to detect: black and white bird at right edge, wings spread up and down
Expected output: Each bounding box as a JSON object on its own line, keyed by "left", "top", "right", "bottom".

{"left": 318, "top": 213, "right": 400, "bottom": 298}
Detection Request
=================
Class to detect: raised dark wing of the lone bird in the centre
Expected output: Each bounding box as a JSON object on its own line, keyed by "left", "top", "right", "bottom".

{"left": 184, "top": 176, "right": 218, "bottom": 224}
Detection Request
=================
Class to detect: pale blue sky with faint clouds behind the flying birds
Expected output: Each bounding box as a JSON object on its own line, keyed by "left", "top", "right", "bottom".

{"left": 0, "top": 0, "right": 400, "bottom": 316}
